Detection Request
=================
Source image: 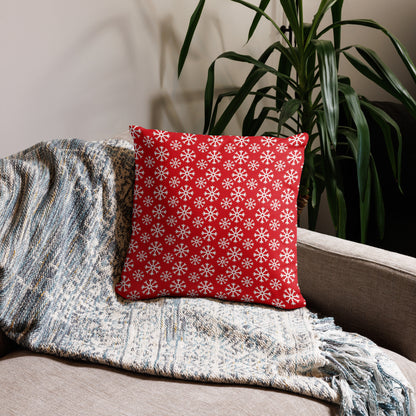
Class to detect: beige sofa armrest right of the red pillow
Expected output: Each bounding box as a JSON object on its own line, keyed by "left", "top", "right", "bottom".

{"left": 298, "top": 228, "right": 416, "bottom": 361}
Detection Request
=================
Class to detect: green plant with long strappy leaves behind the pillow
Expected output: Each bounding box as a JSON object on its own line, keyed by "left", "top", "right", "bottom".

{"left": 178, "top": 0, "right": 416, "bottom": 242}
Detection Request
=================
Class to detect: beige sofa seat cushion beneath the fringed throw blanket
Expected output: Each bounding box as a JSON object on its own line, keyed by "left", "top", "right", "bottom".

{"left": 0, "top": 350, "right": 416, "bottom": 416}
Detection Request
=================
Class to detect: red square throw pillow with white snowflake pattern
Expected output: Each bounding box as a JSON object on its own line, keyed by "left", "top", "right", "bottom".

{"left": 116, "top": 126, "right": 308, "bottom": 309}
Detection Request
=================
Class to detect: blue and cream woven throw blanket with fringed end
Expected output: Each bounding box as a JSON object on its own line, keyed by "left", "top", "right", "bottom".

{"left": 0, "top": 140, "right": 412, "bottom": 415}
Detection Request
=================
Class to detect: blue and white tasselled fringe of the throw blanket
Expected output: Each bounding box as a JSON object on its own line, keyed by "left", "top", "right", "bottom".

{"left": 315, "top": 318, "right": 416, "bottom": 416}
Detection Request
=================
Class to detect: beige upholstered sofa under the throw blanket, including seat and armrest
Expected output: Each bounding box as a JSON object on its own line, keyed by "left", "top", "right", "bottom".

{"left": 0, "top": 229, "right": 416, "bottom": 416}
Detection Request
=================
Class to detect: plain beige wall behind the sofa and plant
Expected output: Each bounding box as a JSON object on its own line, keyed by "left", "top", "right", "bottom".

{"left": 0, "top": 0, "right": 416, "bottom": 157}
